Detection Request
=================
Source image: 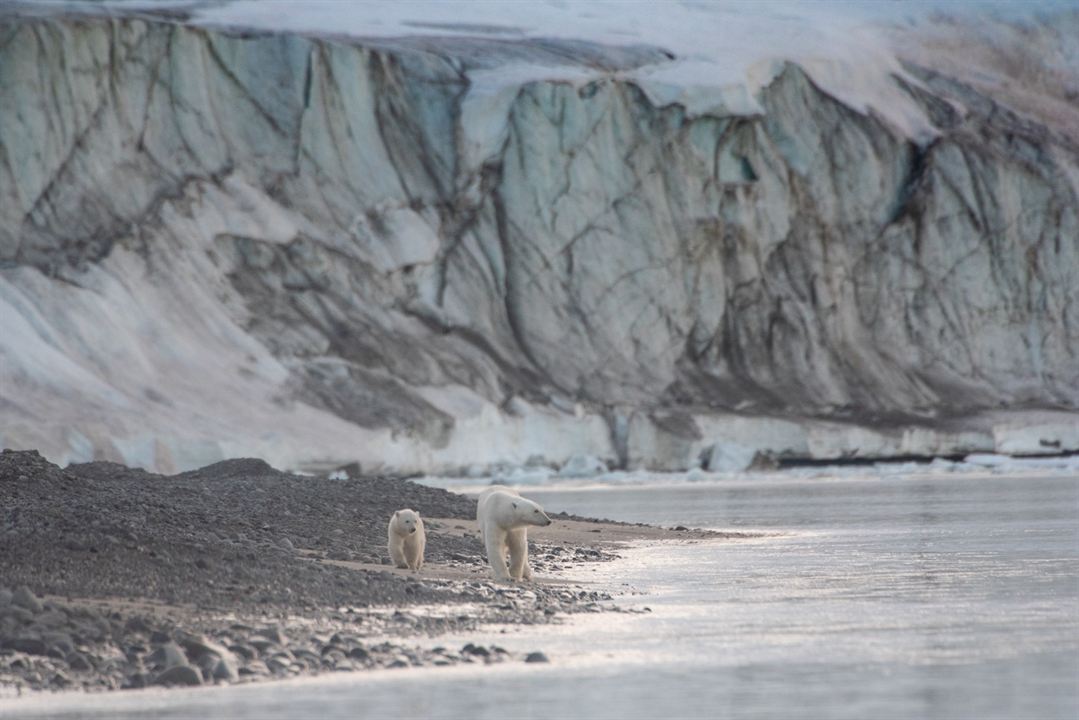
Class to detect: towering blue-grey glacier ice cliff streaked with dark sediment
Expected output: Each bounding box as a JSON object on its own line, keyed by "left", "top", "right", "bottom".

{"left": 0, "top": 1, "right": 1079, "bottom": 471}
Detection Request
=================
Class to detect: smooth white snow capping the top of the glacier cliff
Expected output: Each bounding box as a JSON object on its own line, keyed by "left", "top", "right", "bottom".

{"left": 181, "top": 0, "right": 1066, "bottom": 144}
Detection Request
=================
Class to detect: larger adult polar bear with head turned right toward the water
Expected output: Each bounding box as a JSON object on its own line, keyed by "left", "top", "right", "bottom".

{"left": 476, "top": 485, "right": 550, "bottom": 580}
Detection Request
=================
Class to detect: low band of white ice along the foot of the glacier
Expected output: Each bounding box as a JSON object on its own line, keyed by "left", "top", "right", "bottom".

{"left": 8, "top": 399, "right": 1079, "bottom": 477}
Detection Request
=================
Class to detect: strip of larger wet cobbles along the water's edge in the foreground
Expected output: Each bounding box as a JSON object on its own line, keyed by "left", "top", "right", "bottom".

{"left": 0, "top": 586, "right": 609, "bottom": 695}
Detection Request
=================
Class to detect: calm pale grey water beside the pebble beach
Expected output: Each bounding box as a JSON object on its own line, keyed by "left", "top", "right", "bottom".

{"left": 0, "top": 476, "right": 1079, "bottom": 720}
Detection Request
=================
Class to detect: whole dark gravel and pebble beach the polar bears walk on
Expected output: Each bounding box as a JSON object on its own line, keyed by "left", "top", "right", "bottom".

{"left": 0, "top": 450, "right": 716, "bottom": 695}
